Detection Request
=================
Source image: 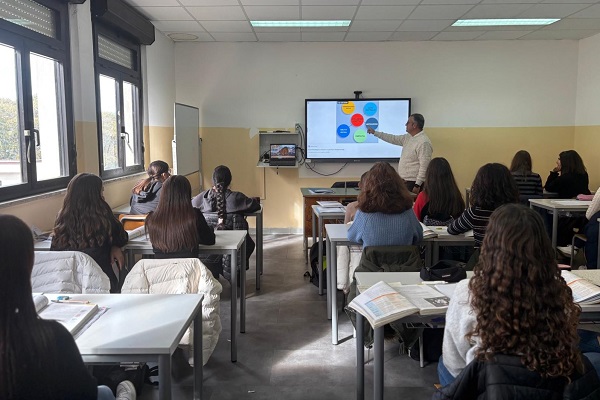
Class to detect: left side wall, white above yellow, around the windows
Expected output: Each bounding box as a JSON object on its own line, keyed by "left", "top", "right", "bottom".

{"left": 0, "top": 2, "right": 178, "bottom": 231}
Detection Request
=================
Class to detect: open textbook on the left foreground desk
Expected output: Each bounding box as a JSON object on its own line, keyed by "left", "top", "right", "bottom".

{"left": 33, "top": 295, "right": 98, "bottom": 335}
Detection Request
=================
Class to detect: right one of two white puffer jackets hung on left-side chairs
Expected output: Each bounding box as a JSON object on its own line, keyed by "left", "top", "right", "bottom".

{"left": 121, "top": 258, "right": 223, "bottom": 365}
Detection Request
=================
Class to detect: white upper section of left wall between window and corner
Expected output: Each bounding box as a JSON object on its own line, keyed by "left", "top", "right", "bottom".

{"left": 142, "top": 30, "right": 175, "bottom": 127}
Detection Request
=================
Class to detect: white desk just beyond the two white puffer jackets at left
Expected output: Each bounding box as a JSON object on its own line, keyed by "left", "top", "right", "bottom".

{"left": 123, "top": 231, "right": 246, "bottom": 362}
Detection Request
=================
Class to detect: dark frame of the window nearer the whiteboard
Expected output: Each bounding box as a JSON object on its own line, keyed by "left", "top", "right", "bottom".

{"left": 92, "top": 20, "right": 144, "bottom": 179}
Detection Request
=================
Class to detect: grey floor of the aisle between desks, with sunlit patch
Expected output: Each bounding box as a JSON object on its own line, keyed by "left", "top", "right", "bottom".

{"left": 141, "top": 235, "right": 438, "bottom": 400}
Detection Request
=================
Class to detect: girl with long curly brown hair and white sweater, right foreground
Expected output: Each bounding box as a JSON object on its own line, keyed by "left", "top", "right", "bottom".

{"left": 434, "top": 204, "right": 600, "bottom": 399}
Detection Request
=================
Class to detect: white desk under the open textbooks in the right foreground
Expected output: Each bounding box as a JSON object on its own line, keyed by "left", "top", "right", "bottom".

{"left": 356, "top": 270, "right": 600, "bottom": 400}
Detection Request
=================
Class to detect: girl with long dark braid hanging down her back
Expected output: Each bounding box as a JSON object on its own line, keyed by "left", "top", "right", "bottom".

{"left": 192, "top": 165, "right": 260, "bottom": 280}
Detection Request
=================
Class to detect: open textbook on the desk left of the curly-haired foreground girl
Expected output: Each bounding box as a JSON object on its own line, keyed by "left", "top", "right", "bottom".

{"left": 348, "top": 282, "right": 450, "bottom": 328}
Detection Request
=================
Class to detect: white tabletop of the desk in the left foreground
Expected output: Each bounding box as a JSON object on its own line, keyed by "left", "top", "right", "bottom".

{"left": 48, "top": 294, "right": 203, "bottom": 354}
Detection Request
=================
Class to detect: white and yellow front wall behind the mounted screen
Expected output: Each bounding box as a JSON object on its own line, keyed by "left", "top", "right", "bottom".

{"left": 175, "top": 41, "right": 584, "bottom": 230}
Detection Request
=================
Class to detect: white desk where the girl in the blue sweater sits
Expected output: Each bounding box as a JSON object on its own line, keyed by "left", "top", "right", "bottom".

{"left": 325, "top": 224, "right": 475, "bottom": 344}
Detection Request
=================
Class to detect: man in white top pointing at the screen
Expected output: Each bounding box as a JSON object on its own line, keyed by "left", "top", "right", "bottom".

{"left": 367, "top": 114, "right": 433, "bottom": 193}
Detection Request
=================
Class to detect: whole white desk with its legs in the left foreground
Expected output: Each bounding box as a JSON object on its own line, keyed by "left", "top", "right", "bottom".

{"left": 49, "top": 294, "right": 203, "bottom": 400}
